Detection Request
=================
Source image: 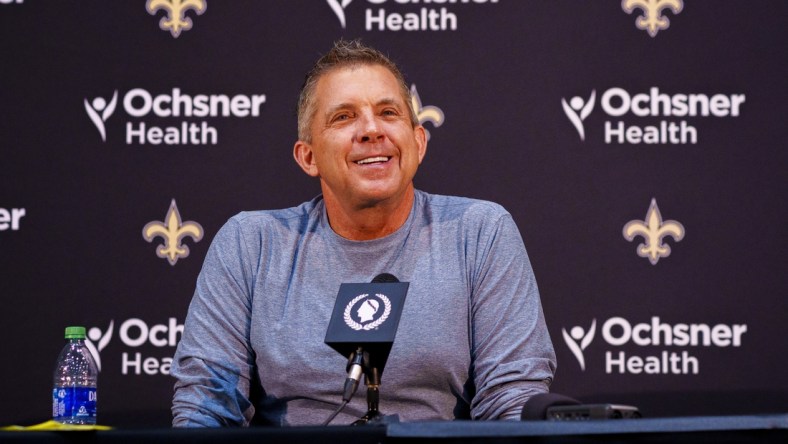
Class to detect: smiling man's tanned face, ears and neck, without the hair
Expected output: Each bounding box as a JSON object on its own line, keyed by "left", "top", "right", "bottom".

{"left": 293, "top": 59, "right": 427, "bottom": 240}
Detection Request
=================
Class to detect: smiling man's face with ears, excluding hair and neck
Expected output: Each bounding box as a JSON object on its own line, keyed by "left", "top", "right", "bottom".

{"left": 294, "top": 65, "right": 427, "bottom": 212}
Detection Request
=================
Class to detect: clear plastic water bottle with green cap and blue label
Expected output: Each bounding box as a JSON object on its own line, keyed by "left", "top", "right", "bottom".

{"left": 52, "top": 327, "right": 98, "bottom": 424}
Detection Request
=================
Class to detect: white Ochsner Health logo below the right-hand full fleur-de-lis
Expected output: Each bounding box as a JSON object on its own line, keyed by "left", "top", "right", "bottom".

{"left": 561, "top": 316, "right": 747, "bottom": 375}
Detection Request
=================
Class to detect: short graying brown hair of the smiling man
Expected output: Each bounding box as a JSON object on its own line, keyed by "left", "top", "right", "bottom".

{"left": 298, "top": 39, "right": 419, "bottom": 143}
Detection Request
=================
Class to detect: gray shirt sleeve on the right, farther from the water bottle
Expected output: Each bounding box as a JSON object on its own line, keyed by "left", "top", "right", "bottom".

{"left": 471, "top": 213, "right": 556, "bottom": 419}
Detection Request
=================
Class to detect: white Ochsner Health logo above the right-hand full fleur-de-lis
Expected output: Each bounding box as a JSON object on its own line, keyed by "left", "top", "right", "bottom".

{"left": 561, "top": 86, "right": 746, "bottom": 145}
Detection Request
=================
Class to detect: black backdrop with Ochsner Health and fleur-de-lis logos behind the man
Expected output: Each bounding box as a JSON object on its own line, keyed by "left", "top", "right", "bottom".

{"left": 0, "top": 0, "right": 788, "bottom": 426}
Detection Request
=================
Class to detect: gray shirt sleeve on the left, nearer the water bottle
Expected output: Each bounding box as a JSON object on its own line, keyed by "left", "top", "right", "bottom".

{"left": 171, "top": 219, "right": 255, "bottom": 427}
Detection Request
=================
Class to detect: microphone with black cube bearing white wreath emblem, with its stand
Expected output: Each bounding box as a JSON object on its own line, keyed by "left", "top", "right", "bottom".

{"left": 324, "top": 273, "right": 409, "bottom": 424}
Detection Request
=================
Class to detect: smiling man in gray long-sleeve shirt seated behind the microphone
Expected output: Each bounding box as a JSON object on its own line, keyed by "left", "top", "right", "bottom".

{"left": 171, "top": 41, "right": 555, "bottom": 427}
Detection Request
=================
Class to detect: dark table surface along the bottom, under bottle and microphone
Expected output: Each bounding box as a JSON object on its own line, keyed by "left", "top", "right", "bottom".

{"left": 0, "top": 413, "right": 788, "bottom": 444}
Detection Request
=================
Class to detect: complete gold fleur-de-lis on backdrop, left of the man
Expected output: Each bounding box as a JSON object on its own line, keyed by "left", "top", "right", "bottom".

{"left": 142, "top": 199, "right": 203, "bottom": 265}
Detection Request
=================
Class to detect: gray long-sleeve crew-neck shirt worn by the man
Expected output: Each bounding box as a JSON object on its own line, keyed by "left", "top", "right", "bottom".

{"left": 171, "top": 191, "right": 555, "bottom": 427}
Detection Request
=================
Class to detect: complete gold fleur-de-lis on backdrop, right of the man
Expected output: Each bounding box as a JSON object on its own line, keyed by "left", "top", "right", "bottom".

{"left": 623, "top": 199, "right": 684, "bottom": 265}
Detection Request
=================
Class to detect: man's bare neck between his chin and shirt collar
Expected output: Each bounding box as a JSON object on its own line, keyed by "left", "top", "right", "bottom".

{"left": 323, "top": 186, "right": 415, "bottom": 241}
